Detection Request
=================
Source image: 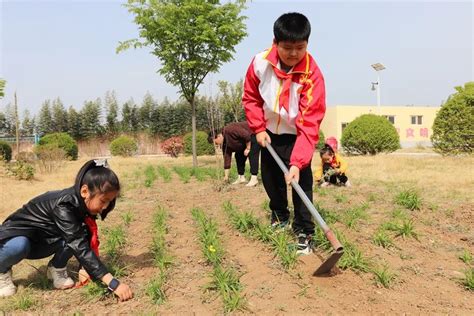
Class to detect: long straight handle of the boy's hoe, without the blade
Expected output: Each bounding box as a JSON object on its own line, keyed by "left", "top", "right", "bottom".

{"left": 266, "top": 142, "right": 342, "bottom": 250}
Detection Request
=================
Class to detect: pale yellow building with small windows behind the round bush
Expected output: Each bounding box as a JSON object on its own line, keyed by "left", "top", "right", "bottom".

{"left": 321, "top": 105, "right": 440, "bottom": 148}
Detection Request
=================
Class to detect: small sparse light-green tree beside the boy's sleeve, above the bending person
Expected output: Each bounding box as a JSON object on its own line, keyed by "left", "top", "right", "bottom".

{"left": 217, "top": 79, "right": 245, "bottom": 123}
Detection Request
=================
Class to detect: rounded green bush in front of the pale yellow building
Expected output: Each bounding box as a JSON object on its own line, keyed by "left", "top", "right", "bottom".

{"left": 341, "top": 114, "right": 400, "bottom": 155}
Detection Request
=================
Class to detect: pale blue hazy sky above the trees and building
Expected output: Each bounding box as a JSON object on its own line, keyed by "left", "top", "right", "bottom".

{"left": 0, "top": 0, "right": 474, "bottom": 114}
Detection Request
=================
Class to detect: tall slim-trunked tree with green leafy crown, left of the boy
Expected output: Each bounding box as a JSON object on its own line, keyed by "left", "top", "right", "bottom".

{"left": 117, "top": 0, "right": 247, "bottom": 167}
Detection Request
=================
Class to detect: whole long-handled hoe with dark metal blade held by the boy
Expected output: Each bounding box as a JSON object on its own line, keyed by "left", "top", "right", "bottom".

{"left": 266, "top": 143, "right": 344, "bottom": 276}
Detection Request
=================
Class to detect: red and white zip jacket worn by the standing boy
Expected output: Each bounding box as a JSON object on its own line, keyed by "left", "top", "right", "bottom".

{"left": 242, "top": 46, "right": 326, "bottom": 169}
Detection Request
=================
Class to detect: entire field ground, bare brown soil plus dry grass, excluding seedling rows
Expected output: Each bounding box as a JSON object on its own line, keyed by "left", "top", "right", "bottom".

{"left": 0, "top": 155, "right": 474, "bottom": 315}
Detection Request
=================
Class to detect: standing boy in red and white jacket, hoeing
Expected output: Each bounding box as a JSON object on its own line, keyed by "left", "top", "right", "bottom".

{"left": 242, "top": 13, "right": 326, "bottom": 254}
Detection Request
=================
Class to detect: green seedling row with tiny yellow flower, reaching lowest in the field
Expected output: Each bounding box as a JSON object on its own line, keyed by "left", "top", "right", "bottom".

{"left": 191, "top": 208, "right": 246, "bottom": 313}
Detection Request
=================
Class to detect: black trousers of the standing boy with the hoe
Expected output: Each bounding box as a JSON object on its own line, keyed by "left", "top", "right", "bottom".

{"left": 261, "top": 131, "right": 314, "bottom": 235}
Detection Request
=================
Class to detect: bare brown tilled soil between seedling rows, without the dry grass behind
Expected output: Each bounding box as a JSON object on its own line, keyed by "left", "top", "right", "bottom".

{"left": 0, "top": 157, "right": 474, "bottom": 315}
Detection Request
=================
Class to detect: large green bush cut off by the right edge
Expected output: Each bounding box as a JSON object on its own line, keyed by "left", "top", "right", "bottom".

{"left": 431, "top": 81, "right": 474, "bottom": 154}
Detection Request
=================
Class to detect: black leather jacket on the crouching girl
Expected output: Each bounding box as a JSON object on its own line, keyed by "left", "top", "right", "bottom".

{"left": 0, "top": 187, "right": 108, "bottom": 279}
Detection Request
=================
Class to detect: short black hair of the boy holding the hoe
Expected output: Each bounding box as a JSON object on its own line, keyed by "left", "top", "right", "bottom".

{"left": 273, "top": 12, "right": 311, "bottom": 43}
